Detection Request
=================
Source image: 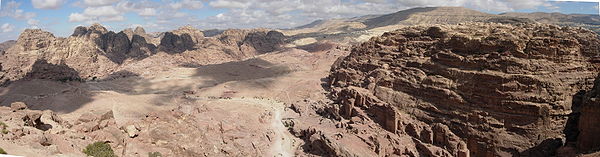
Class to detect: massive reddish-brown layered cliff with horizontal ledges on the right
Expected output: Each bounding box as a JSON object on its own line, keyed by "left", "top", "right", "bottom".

{"left": 329, "top": 23, "right": 600, "bottom": 156}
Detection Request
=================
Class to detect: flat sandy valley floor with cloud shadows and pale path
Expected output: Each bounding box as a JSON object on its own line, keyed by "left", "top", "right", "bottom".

{"left": 0, "top": 45, "right": 347, "bottom": 156}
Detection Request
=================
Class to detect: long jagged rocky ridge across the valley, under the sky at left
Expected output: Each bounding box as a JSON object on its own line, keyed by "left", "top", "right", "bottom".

{"left": 0, "top": 24, "right": 285, "bottom": 82}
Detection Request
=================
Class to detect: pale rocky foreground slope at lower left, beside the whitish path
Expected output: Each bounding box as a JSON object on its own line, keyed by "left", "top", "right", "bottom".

{"left": 0, "top": 100, "right": 282, "bottom": 157}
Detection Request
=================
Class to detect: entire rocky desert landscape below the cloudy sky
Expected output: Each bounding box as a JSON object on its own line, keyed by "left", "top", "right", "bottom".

{"left": 0, "top": 2, "right": 600, "bottom": 157}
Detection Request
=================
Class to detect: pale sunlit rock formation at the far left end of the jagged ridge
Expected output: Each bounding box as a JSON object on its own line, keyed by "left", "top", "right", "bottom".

{"left": 0, "top": 25, "right": 120, "bottom": 80}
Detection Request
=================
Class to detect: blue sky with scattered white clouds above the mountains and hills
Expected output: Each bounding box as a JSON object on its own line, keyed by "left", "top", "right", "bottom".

{"left": 0, "top": 0, "right": 600, "bottom": 42}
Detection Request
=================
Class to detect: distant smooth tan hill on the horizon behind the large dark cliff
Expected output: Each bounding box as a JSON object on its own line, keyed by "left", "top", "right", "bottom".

{"left": 284, "top": 7, "right": 600, "bottom": 42}
